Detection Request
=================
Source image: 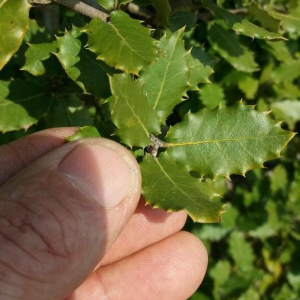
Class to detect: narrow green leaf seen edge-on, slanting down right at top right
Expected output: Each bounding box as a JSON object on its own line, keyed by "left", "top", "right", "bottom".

{"left": 202, "top": 0, "right": 285, "bottom": 40}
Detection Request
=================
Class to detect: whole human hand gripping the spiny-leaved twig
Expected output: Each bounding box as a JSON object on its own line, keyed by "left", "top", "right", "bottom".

{"left": 0, "top": 128, "right": 207, "bottom": 300}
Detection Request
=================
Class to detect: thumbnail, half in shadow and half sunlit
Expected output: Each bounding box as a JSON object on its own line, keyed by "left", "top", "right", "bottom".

{"left": 58, "top": 142, "right": 138, "bottom": 208}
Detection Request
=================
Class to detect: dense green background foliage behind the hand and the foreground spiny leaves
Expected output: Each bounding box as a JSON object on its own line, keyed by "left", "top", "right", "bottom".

{"left": 0, "top": 0, "right": 300, "bottom": 300}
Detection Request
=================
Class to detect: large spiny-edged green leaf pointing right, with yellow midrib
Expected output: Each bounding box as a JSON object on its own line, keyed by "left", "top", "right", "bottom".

{"left": 166, "top": 103, "right": 294, "bottom": 178}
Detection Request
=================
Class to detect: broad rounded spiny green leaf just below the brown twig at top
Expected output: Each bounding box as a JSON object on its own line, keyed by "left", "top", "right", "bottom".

{"left": 84, "top": 11, "right": 159, "bottom": 75}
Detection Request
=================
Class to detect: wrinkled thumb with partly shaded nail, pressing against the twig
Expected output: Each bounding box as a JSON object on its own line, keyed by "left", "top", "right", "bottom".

{"left": 0, "top": 139, "right": 141, "bottom": 300}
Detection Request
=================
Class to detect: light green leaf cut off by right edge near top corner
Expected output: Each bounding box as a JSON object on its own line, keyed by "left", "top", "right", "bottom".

{"left": 270, "top": 5, "right": 300, "bottom": 36}
